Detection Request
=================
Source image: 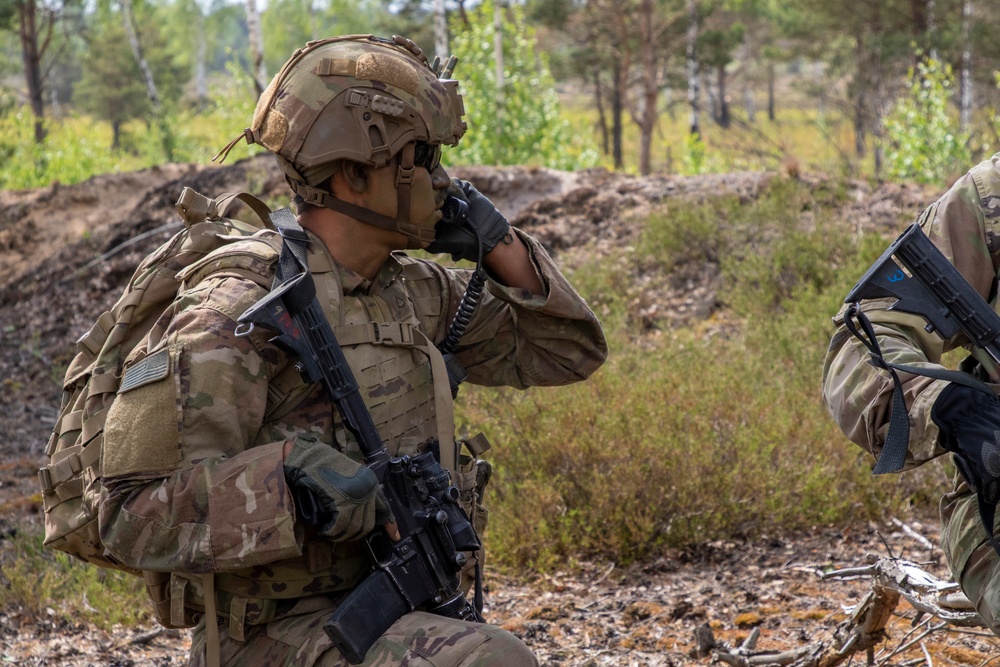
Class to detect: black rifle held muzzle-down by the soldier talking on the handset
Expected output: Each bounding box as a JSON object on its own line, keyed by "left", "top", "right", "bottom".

{"left": 238, "top": 209, "right": 482, "bottom": 664}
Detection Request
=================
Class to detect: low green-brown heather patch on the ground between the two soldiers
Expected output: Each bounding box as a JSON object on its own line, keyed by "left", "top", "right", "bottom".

{"left": 461, "top": 182, "right": 928, "bottom": 568}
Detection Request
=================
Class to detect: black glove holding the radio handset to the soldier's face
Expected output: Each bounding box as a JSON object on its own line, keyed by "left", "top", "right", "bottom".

{"left": 427, "top": 178, "right": 510, "bottom": 262}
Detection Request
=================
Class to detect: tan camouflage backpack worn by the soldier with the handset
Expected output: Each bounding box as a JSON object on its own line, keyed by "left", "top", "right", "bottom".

{"left": 38, "top": 188, "right": 273, "bottom": 574}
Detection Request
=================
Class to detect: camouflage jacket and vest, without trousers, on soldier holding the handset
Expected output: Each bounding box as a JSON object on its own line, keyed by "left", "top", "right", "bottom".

{"left": 99, "top": 231, "right": 607, "bottom": 616}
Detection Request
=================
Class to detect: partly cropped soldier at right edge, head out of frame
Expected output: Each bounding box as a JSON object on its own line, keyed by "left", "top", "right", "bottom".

{"left": 823, "top": 154, "right": 1000, "bottom": 635}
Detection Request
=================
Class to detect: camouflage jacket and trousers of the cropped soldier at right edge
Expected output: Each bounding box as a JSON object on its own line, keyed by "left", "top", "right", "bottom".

{"left": 823, "top": 154, "right": 1000, "bottom": 635}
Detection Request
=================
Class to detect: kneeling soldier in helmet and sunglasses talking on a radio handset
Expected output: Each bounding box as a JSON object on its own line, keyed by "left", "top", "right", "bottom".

{"left": 99, "top": 35, "right": 607, "bottom": 667}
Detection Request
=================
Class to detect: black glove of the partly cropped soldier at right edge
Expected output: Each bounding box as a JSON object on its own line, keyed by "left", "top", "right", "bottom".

{"left": 931, "top": 383, "right": 1000, "bottom": 505}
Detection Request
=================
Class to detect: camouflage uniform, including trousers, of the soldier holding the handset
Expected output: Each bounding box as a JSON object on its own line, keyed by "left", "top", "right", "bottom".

{"left": 99, "top": 223, "right": 607, "bottom": 666}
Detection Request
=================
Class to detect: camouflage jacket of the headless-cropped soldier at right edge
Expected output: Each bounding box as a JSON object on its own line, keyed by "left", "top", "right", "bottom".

{"left": 823, "top": 153, "right": 1000, "bottom": 468}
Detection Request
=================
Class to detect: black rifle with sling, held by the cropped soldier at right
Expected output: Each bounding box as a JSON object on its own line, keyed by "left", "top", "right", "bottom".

{"left": 844, "top": 224, "right": 1000, "bottom": 554}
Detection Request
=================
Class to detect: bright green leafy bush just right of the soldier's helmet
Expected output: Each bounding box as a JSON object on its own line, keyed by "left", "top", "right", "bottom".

{"left": 447, "top": 0, "right": 598, "bottom": 169}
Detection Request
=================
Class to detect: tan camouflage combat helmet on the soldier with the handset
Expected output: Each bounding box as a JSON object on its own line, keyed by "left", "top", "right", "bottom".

{"left": 250, "top": 35, "right": 466, "bottom": 171}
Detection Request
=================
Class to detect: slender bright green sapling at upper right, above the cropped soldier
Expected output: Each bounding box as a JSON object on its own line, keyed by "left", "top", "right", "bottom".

{"left": 885, "top": 54, "right": 972, "bottom": 185}
